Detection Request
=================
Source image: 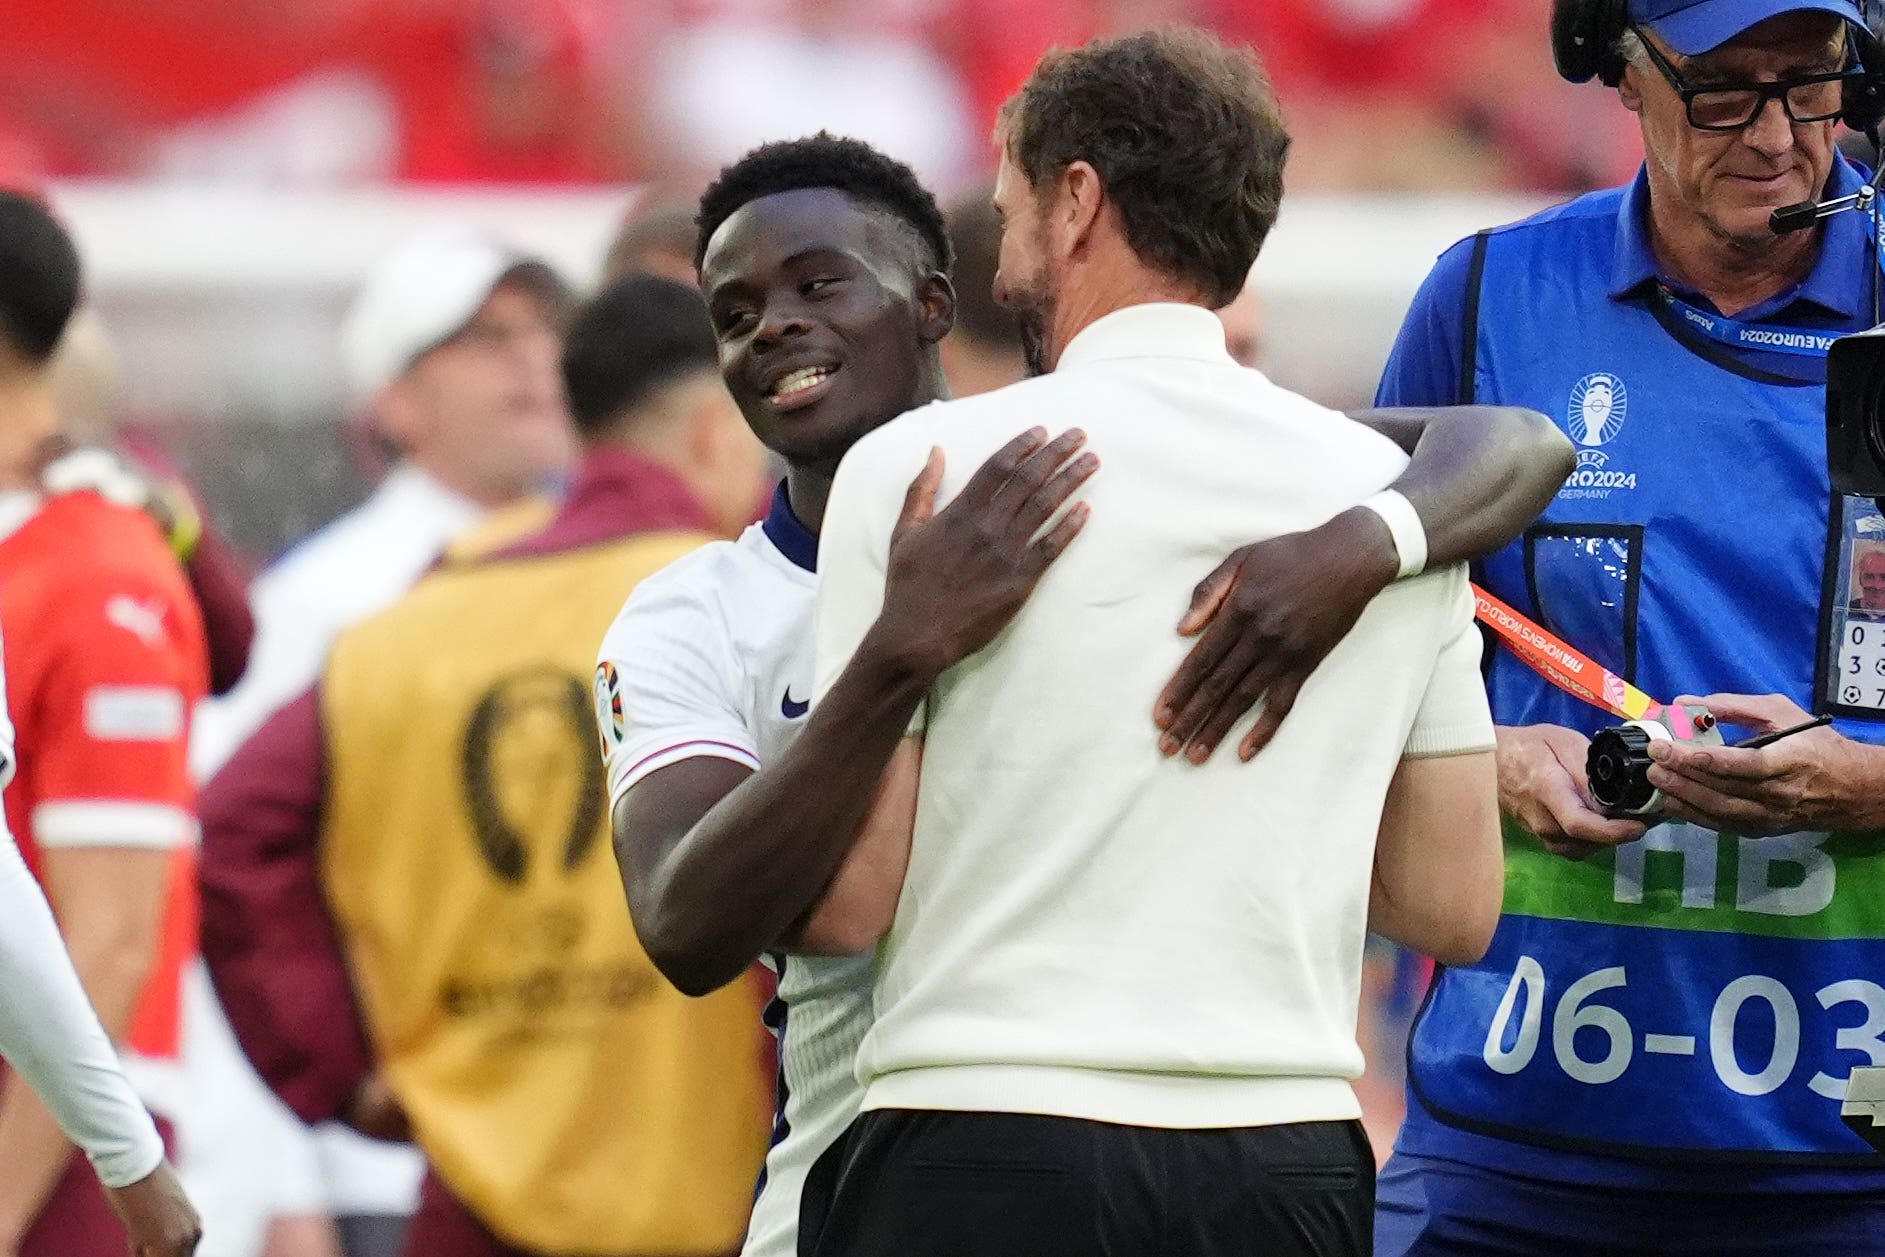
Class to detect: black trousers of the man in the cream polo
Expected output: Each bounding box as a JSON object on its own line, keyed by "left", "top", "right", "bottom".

{"left": 799, "top": 1108, "right": 1374, "bottom": 1257}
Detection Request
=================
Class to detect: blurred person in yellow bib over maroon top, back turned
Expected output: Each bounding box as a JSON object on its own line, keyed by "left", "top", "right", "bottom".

{"left": 204, "top": 275, "right": 769, "bottom": 1257}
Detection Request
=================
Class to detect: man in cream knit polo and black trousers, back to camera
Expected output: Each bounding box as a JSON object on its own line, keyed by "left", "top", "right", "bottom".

{"left": 801, "top": 30, "right": 1500, "bottom": 1257}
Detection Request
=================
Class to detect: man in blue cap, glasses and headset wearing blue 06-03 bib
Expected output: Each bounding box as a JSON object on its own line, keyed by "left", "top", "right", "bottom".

{"left": 1376, "top": 0, "right": 1885, "bottom": 1257}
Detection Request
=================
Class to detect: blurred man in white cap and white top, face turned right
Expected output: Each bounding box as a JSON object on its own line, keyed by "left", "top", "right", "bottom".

{"left": 192, "top": 228, "right": 575, "bottom": 1257}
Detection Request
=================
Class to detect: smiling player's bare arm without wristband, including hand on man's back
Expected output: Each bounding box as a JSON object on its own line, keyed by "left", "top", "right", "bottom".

{"left": 615, "top": 428, "right": 1099, "bottom": 995}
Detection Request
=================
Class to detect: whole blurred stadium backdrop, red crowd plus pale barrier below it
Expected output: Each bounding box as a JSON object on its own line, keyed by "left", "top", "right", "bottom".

{"left": 18, "top": 0, "right": 1640, "bottom": 1183}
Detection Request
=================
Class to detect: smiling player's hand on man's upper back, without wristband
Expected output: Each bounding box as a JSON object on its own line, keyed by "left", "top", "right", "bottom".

{"left": 873, "top": 428, "right": 1099, "bottom": 677}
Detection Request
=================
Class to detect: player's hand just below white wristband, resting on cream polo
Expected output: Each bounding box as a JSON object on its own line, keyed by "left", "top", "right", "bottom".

{"left": 1152, "top": 507, "right": 1399, "bottom": 763}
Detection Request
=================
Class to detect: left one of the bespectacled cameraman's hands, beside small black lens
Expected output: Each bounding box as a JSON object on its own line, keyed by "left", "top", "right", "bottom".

{"left": 1497, "top": 724, "right": 1649, "bottom": 859}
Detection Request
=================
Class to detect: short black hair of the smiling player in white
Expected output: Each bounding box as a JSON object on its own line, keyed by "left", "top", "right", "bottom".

{"left": 694, "top": 132, "right": 956, "bottom": 275}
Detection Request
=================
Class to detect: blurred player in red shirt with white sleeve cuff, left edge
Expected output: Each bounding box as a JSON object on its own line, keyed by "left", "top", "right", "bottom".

{"left": 0, "top": 194, "right": 207, "bottom": 1257}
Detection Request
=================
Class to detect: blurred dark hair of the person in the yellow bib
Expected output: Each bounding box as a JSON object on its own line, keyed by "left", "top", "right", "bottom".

{"left": 564, "top": 273, "right": 720, "bottom": 437}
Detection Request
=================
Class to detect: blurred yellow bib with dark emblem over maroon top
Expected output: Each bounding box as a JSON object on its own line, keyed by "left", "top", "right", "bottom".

{"left": 322, "top": 533, "right": 769, "bottom": 1257}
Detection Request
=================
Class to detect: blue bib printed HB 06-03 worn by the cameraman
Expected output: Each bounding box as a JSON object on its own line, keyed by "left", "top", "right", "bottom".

{"left": 1402, "top": 171, "right": 1885, "bottom": 1185}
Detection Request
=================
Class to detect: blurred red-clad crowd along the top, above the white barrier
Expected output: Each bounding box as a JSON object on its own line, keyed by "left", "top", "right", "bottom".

{"left": 0, "top": 0, "right": 1636, "bottom": 194}
